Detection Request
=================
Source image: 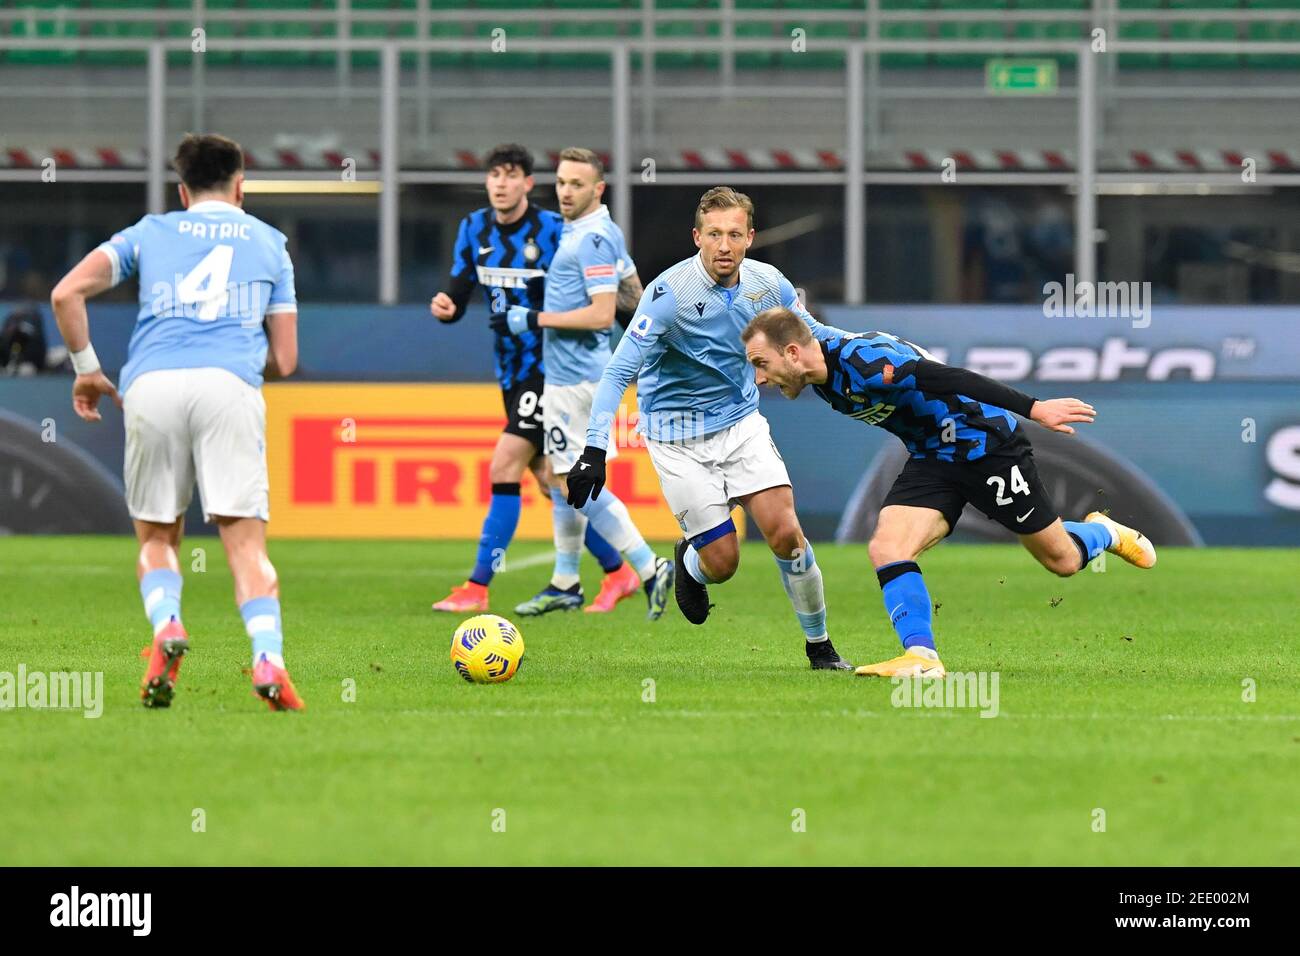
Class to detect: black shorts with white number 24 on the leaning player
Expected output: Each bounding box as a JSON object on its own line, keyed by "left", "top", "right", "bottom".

{"left": 884, "top": 442, "right": 1057, "bottom": 535}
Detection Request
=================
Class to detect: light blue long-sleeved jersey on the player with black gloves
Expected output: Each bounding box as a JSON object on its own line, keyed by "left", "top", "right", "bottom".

{"left": 586, "top": 255, "right": 848, "bottom": 449}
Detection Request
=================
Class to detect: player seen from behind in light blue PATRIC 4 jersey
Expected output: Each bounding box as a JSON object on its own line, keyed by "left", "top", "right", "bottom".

{"left": 51, "top": 134, "right": 304, "bottom": 710}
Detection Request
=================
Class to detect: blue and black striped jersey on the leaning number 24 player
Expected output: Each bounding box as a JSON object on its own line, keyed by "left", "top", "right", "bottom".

{"left": 813, "top": 332, "right": 1034, "bottom": 462}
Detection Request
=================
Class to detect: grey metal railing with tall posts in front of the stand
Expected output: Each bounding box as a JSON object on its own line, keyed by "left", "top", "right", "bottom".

{"left": 0, "top": 35, "right": 1300, "bottom": 303}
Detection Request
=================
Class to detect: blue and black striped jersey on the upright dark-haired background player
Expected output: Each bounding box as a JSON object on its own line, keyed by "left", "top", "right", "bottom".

{"left": 451, "top": 203, "right": 564, "bottom": 389}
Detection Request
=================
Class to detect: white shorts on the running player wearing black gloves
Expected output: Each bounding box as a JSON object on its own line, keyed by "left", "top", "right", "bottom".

{"left": 646, "top": 411, "right": 790, "bottom": 538}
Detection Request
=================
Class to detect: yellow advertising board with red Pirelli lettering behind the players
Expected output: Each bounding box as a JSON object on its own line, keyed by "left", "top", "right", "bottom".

{"left": 264, "top": 382, "right": 681, "bottom": 540}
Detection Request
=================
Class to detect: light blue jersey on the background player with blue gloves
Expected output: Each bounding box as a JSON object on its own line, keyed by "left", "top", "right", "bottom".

{"left": 542, "top": 206, "right": 637, "bottom": 385}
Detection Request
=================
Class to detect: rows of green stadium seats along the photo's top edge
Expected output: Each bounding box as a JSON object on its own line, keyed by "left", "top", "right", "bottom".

{"left": 0, "top": 0, "right": 1300, "bottom": 70}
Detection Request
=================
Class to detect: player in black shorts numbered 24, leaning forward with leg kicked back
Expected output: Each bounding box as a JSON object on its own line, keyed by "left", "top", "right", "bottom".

{"left": 741, "top": 308, "right": 1156, "bottom": 678}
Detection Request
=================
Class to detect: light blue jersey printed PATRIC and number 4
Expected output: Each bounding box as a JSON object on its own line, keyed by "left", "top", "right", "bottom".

{"left": 100, "top": 200, "right": 298, "bottom": 394}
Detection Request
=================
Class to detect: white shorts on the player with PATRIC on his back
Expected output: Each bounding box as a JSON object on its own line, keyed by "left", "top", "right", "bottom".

{"left": 122, "top": 368, "right": 270, "bottom": 524}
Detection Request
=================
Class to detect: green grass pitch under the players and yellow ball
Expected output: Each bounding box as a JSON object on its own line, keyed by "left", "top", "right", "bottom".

{"left": 0, "top": 538, "right": 1300, "bottom": 865}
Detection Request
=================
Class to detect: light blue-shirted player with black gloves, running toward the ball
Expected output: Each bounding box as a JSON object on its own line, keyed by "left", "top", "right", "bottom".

{"left": 569, "top": 186, "right": 852, "bottom": 670}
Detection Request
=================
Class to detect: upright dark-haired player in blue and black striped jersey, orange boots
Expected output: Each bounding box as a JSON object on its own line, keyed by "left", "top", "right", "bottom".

{"left": 429, "top": 143, "right": 641, "bottom": 614}
